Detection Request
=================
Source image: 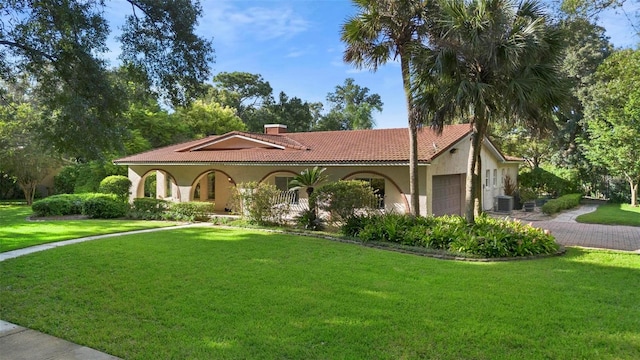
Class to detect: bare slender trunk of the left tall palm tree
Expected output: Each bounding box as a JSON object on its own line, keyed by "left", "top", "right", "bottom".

{"left": 400, "top": 55, "right": 420, "bottom": 216}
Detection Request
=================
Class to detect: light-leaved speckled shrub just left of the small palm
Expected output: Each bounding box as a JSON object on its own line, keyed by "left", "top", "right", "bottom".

{"left": 231, "top": 181, "right": 290, "bottom": 225}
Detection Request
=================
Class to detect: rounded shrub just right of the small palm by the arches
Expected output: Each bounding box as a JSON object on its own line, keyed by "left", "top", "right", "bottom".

{"left": 310, "top": 180, "right": 378, "bottom": 224}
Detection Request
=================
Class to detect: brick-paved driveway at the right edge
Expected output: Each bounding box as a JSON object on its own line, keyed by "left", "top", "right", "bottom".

{"left": 532, "top": 205, "right": 640, "bottom": 254}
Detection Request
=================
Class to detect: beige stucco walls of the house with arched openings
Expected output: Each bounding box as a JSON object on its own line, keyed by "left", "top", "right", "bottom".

{"left": 129, "top": 141, "right": 518, "bottom": 215}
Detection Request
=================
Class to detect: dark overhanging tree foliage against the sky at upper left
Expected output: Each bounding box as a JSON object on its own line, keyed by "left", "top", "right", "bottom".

{"left": 0, "top": 0, "right": 213, "bottom": 158}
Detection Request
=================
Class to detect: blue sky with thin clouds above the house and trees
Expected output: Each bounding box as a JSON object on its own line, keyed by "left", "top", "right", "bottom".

{"left": 107, "top": 0, "right": 640, "bottom": 128}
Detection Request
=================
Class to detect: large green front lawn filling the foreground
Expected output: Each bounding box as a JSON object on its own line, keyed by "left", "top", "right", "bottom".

{"left": 0, "top": 228, "right": 640, "bottom": 359}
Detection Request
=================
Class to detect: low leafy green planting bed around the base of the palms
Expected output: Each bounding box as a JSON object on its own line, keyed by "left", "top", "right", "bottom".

{"left": 342, "top": 214, "right": 558, "bottom": 258}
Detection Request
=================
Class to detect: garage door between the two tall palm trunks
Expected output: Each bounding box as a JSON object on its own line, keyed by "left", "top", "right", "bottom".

{"left": 431, "top": 174, "right": 464, "bottom": 216}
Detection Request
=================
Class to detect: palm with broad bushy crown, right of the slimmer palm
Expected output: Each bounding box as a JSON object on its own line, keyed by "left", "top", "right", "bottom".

{"left": 413, "top": 0, "right": 566, "bottom": 223}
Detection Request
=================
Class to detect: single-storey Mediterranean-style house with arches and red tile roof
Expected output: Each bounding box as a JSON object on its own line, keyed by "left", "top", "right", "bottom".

{"left": 114, "top": 124, "right": 522, "bottom": 216}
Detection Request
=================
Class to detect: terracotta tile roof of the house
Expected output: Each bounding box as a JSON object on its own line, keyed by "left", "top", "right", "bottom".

{"left": 115, "top": 124, "right": 478, "bottom": 164}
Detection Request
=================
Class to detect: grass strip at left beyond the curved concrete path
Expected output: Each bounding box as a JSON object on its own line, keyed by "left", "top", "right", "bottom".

{"left": 0, "top": 205, "right": 176, "bottom": 252}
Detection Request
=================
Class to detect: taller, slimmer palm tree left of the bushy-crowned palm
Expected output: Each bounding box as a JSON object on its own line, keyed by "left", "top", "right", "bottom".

{"left": 341, "top": 0, "right": 430, "bottom": 215}
